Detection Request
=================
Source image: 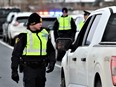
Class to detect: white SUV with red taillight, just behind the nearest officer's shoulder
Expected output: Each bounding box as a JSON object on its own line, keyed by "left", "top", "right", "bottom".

{"left": 8, "top": 12, "right": 32, "bottom": 45}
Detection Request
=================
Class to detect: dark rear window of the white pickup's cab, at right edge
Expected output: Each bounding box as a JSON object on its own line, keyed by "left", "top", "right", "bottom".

{"left": 102, "top": 14, "right": 116, "bottom": 42}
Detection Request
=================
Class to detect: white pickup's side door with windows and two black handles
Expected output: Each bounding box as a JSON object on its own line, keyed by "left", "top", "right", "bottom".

{"left": 69, "top": 15, "right": 101, "bottom": 87}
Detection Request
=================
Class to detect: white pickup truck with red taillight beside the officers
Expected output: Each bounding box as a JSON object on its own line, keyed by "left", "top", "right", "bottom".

{"left": 61, "top": 6, "right": 116, "bottom": 87}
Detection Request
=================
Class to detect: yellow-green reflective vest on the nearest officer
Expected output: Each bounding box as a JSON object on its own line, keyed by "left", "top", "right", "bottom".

{"left": 23, "top": 29, "right": 48, "bottom": 55}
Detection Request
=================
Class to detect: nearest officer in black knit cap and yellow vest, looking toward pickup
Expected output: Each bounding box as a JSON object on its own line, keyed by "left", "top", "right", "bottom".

{"left": 11, "top": 13, "right": 56, "bottom": 87}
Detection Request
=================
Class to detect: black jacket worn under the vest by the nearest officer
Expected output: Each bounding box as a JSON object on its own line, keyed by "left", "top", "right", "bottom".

{"left": 11, "top": 28, "right": 56, "bottom": 69}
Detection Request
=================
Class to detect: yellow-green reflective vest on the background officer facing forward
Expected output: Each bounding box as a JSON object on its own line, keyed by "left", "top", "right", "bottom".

{"left": 57, "top": 16, "right": 71, "bottom": 30}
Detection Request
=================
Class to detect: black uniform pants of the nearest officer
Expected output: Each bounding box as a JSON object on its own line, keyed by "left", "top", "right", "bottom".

{"left": 23, "top": 62, "right": 46, "bottom": 87}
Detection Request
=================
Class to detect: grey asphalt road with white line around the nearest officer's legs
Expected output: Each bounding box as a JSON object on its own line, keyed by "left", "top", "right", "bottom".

{"left": 0, "top": 41, "right": 60, "bottom": 87}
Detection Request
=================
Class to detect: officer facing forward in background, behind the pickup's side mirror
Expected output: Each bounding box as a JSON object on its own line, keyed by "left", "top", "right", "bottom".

{"left": 53, "top": 8, "right": 76, "bottom": 61}
